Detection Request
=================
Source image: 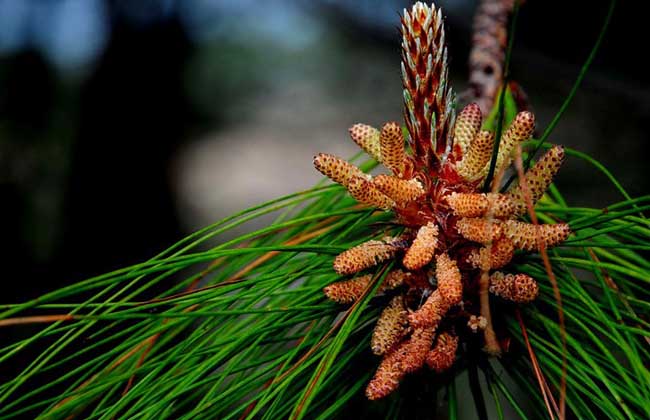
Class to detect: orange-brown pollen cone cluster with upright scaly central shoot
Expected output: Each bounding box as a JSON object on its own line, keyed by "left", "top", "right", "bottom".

{"left": 314, "top": 2, "right": 570, "bottom": 400}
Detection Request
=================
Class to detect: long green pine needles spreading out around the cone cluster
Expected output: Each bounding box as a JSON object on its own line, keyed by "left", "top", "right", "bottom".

{"left": 0, "top": 2, "right": 650, "bottom": 419}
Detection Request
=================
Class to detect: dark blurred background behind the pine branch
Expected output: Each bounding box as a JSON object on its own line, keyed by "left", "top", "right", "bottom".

{"left": 0, "top": 0, "right": 650, "bottom": 302}
